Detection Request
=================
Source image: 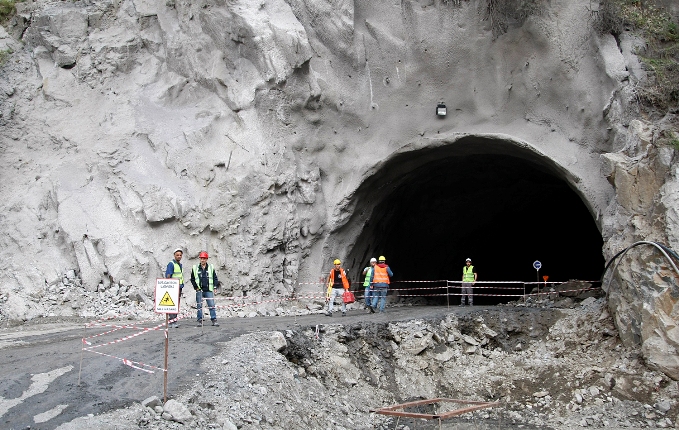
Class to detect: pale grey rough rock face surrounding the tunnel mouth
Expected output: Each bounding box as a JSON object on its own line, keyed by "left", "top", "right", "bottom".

{"left": 0, "top": 0, "right": 679, "bottom": 377}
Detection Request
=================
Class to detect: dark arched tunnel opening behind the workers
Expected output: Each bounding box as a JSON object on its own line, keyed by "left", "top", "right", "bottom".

{"left": 348, "top": 137, "right": 605, "bottom": 302}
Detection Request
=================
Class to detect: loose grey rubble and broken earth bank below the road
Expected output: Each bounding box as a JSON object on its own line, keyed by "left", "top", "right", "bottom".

{"left": 19, "top": 297, "right": 679, "bottom": 430}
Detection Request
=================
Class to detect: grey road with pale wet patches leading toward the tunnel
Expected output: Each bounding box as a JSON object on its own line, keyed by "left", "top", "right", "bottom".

{"left": 0, "top": 306, "right": 525, "bottom": 430}
